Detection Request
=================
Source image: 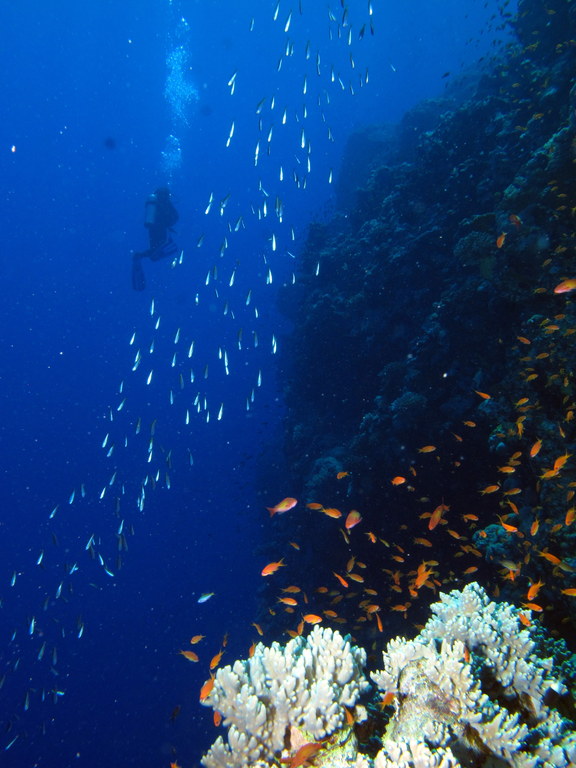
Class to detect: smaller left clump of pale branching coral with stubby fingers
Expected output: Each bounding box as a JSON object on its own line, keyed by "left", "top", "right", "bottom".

{"left": 202, "top": 627, "right": 370, "bottom": 768}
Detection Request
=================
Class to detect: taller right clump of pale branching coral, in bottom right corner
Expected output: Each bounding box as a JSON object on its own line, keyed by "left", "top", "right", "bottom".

{"left": 372, "top": 584, "right": 576, "bottom": 768}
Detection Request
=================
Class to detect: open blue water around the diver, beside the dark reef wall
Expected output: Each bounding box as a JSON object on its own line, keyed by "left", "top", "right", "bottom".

{"left": 0, "top": 0, "right": 511, "bottom": 768}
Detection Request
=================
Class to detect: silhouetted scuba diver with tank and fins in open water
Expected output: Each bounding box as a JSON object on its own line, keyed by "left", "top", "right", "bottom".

{"left": 132, "top": 187, "right": 178, "bottom": 291}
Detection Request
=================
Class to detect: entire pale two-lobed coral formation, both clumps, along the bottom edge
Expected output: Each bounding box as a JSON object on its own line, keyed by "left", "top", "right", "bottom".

{"left": 202, "top": 583, "right": 576, "bottom": 768}
